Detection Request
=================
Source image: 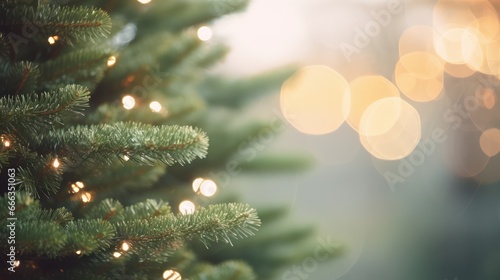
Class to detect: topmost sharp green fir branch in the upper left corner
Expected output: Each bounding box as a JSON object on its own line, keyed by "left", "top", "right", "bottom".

{"left": 0, "top": 4, "right": 111, "bottom": 44}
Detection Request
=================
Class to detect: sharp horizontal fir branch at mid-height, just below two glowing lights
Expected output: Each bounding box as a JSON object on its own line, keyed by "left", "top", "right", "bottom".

{"left": 33, "top": 123, "right": 208, "bottom": 165}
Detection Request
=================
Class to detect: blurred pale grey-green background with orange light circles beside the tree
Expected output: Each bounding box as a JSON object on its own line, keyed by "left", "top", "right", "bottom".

{"left": 206, "top": 0, "right": 500, "bottom": 280}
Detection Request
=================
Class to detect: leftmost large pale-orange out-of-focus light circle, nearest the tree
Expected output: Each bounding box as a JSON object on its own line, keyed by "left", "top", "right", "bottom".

{"left": 280, "top": 65, "right": 351, "bottom": 135}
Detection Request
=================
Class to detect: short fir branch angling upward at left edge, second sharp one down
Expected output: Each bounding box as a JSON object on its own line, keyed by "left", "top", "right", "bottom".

{"left": 0, "top": 85, "right": 89, "bottom": 133}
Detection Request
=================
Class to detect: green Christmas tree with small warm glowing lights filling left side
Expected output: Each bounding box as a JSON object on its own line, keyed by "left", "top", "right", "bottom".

{"left": 0, "top": 0, "right": 338, "bottom": 280}
